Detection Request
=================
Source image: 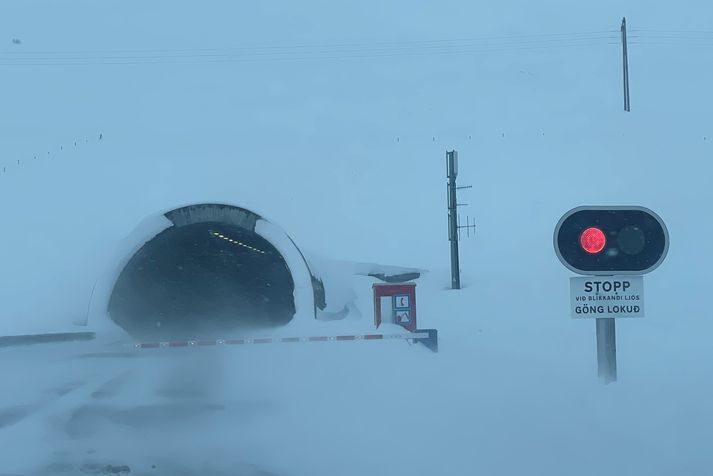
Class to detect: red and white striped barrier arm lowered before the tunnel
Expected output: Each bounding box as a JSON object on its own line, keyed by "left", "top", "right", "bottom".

{"left": 125, "top": 329, "right": 437, "bottom": 352}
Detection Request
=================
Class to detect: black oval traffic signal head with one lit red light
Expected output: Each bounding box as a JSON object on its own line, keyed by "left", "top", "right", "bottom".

{"left": 554, "top": 207, "right": 668, "bottom": 275}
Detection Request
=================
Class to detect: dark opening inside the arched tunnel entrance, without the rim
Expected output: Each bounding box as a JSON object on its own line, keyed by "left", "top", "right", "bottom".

{"left": 108, "top": 222, "right": 295, "bottom": 339}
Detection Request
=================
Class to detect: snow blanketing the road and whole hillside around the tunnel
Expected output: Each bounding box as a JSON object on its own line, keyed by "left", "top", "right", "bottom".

{"left": 0, "top": 0, "right": 713, "bottom": 476}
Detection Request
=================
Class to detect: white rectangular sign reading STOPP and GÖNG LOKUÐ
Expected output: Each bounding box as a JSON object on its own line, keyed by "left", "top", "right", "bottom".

{"left": 569, "top": 276, "right": 644, "bottom": 319}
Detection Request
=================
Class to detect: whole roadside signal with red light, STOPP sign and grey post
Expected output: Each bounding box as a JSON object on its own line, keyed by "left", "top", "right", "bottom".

{"left": 554, "top": 207, "right": 669, "bottom": 383}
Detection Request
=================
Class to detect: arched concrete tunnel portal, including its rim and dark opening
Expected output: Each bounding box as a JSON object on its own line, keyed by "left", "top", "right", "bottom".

{"left": 106, "top": 204, "right": 323, "bottom": 339}
